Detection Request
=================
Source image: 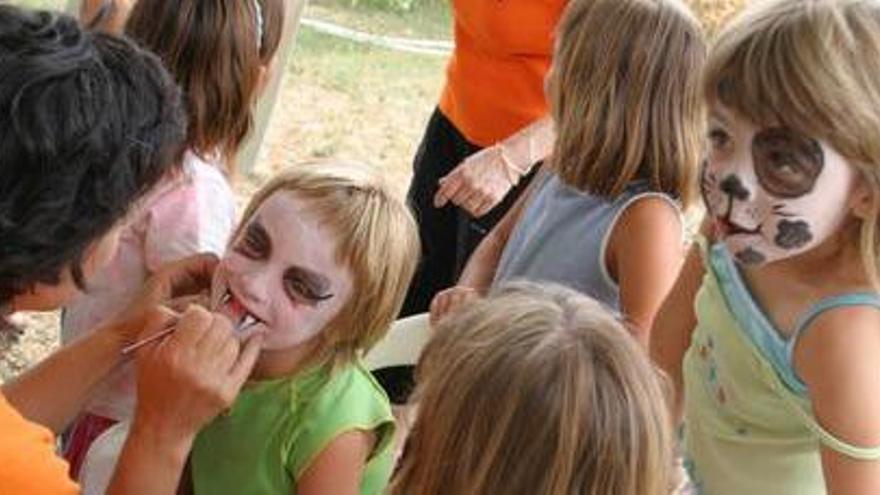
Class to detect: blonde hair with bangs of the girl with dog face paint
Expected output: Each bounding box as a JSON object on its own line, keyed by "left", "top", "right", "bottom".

{"left": 703, "top": 0, "right": 880, "bottom": 287}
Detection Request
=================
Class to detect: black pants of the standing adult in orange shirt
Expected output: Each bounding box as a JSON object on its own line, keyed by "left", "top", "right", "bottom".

{"left": 401, "top": 109, "right": 528, "bottom": 316}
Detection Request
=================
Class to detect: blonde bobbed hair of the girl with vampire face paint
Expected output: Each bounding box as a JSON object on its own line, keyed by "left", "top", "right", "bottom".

{"left": 233, "top": 161, "right": 420, "bottom": 366}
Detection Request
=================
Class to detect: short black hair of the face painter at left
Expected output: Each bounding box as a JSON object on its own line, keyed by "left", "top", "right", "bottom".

{"left": 0, "top": 5, "right": 185, "bottom": 305}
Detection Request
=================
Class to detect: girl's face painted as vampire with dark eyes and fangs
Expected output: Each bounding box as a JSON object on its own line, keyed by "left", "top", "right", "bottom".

{"left": 212, "top": 191, "right": 352, "bottom": 350}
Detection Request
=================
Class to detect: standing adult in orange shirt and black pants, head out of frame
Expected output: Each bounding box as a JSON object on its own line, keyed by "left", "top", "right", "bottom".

{"left": 403, "top": 0, "right": 566, "bottom": 315}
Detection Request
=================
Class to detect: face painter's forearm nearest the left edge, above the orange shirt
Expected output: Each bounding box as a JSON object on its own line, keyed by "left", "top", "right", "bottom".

{"left": 3, "top": 324, "right": 122, "bottom": 433}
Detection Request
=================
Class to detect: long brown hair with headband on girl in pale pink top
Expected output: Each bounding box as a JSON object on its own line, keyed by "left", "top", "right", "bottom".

{"left": 125, "top": 0, "right": 285, "bottom": 167}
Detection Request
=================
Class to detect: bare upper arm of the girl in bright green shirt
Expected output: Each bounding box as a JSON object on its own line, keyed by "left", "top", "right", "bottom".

{"left": 296, "top": 430, "right": 376, "bottom": 495}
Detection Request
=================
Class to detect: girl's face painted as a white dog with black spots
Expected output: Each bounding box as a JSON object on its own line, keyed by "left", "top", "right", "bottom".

{"left": 702, "top": 105, "right": 856, "bottom": 265}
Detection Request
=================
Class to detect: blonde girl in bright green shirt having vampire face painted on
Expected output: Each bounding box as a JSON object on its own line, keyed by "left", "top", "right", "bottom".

{"left": 191, "top": 163, "right": 419, "bottom": 495}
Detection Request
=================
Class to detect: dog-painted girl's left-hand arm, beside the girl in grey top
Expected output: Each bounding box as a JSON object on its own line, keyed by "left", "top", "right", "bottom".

{"left": 650, "top": 223, "right": 709, "bottom": 418}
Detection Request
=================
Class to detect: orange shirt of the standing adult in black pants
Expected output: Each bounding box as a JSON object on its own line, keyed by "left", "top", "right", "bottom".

{"left": 440, "top": 0, "right": 566, "bottom": 146}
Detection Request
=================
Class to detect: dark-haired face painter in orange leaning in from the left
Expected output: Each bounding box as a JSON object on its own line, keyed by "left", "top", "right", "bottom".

{"left": 0, "top": 4, "right": 261, "bottom": 495}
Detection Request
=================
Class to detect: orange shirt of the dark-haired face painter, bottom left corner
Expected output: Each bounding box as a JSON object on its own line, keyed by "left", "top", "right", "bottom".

{"left": 0, "top": 393, "right": 79, "bottom": 495}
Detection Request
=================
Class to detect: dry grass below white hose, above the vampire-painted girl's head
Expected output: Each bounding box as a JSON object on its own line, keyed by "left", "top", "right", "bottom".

{"left": 257, "top": 9, "right": 446, "bottom": 193}
